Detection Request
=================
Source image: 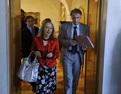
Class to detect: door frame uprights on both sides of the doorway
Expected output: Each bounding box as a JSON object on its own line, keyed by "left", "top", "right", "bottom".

{"left": 5, "top": 0, "right": 108, "bottom": 94}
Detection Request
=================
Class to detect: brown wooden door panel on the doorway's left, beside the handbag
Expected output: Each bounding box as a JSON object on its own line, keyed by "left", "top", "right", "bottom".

{"left": 9, "top": 0, "right": 21, "bottom": 94}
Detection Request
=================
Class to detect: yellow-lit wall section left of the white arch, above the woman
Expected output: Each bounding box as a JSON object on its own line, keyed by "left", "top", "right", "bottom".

{"left": 21, "top": 0, "right": 60, "bottom": 31}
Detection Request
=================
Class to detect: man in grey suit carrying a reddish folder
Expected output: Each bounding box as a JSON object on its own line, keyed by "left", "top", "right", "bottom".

{"left": 58, "top": 8, "right": 89, "bottom": 94}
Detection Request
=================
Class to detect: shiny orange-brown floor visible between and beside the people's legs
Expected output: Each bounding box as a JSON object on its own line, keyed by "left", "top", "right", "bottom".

{"left": 18, "top": 57, "right": 91, "bottom": 94}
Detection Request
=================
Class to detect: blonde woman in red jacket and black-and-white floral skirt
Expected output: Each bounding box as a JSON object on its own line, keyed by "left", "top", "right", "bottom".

{"left": 31, "top": 20, "right": 59, "bottom": 94}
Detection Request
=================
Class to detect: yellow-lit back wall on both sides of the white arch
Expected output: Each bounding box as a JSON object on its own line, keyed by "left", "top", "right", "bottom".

{"left": 21, "top": 0, "right": 88, "bottom": 31}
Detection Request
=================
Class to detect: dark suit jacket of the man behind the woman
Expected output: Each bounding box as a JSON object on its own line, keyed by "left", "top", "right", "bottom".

{"left": 21, "top": 27, "right": 39, "bottom": 58}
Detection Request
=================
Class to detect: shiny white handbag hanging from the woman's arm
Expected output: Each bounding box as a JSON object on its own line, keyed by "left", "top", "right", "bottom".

{"left": 17, "top": 51, "right": 39, "bottom": 82}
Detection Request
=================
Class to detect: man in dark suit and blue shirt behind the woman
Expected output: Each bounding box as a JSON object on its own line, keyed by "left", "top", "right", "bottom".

{"left": 22, "top": 16, "right": 39, "bottom": 58}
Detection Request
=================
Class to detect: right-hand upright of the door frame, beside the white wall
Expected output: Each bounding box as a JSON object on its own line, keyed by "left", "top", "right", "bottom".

{"left": 95, "top": 0, "right": 108, "bottom": 94}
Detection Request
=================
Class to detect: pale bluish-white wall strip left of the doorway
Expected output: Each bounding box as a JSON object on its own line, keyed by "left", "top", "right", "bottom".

{"left": 0, "top": 0, "right": 9, "bottom": 94}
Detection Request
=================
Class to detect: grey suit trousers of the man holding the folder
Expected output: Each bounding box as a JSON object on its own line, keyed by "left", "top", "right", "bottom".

{"left": 62, "top": 52, "right": 81, "bottom": 94}
